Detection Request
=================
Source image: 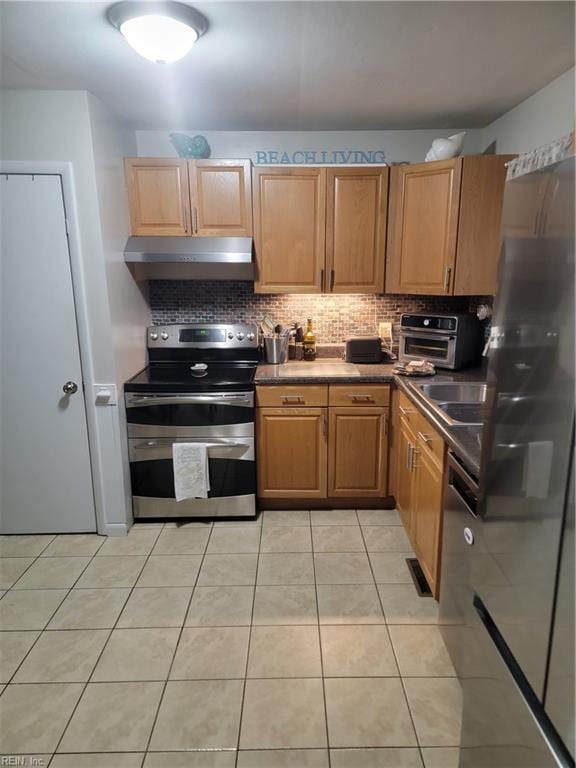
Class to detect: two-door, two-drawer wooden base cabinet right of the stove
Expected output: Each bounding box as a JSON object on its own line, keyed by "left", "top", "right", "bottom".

{"left": 256, "top": 385, "right": 390, "bottom": 504}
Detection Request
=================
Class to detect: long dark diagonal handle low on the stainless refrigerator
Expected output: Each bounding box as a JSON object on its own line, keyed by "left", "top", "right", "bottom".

{"left": 472, "top": 594, "right": 574, "bottom": 768}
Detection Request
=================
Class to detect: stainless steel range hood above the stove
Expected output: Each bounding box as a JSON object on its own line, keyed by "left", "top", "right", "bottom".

{"left": 124, "top": 237, "right": 254, "bottom": 280}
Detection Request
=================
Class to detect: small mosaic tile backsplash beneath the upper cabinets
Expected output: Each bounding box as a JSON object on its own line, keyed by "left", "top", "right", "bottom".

{"left": 150, "top": 280, "right": 492, "bottom": 344}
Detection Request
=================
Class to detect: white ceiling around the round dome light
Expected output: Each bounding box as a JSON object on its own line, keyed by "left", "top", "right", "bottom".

{"left": 0, "top": 2, "right": 574, "bottom": 130}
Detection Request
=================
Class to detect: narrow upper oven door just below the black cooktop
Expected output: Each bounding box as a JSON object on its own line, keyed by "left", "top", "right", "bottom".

{"left": 124, "top": 392, "right": 254, "bottom": 437}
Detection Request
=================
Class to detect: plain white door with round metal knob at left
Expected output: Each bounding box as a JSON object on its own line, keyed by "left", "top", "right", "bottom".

{"left": 0, "top": 174, "right": 96, "bottom": 533}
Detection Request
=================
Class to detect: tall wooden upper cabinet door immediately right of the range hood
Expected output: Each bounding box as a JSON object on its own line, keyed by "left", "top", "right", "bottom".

{"left": 253, "top": 167, "right": 326, "bottom": 293}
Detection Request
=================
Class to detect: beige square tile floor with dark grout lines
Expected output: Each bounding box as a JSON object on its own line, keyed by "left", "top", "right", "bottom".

{"left": 0, "top": 510, "right": 461, "bottom": 768}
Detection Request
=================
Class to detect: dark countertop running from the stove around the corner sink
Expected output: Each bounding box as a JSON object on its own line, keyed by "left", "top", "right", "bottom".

{"left": 255, "top": 358, "right": 486, "bottom": 477}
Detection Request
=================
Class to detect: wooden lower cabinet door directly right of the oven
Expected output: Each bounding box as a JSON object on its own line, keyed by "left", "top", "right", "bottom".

{"left": 257, "top": 408, "right": 328, "bottom": 499}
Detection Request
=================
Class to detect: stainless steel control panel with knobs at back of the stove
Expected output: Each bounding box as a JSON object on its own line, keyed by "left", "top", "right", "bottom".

{"left": 146, "top": 323, "right": 259, "bottom": 349}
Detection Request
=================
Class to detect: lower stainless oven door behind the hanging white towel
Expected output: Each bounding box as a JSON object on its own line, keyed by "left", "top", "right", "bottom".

{"left": 128, "top": 437, "right": 256, "bottom": 517}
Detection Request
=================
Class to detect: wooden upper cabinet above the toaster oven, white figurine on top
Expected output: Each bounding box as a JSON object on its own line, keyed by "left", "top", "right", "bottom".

{"left": 386, "top": 155, "right": 513, "bottom": 296}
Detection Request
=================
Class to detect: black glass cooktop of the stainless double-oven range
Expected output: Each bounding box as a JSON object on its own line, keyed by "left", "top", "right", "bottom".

{"left": 124, "top": 362, "right": 256, "bottom": 392}
